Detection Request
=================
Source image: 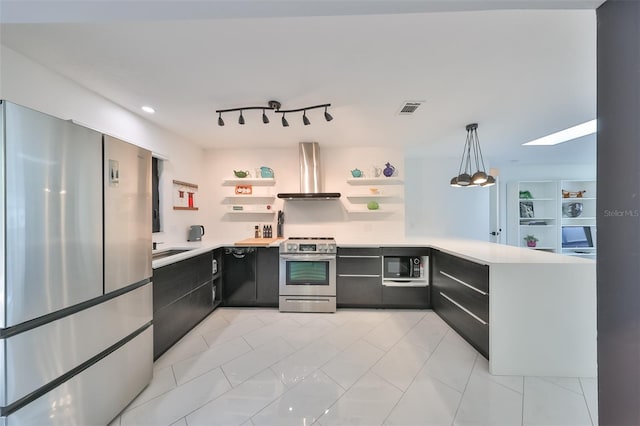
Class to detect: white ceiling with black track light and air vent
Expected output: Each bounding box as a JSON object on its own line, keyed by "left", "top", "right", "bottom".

{"left": 0, "top": 0, "right": 602, "bottom": 163}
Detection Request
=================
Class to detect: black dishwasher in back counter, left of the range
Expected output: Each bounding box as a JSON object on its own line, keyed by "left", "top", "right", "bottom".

{"left": 222, "top": 247, "right": 257, "bottom": 306}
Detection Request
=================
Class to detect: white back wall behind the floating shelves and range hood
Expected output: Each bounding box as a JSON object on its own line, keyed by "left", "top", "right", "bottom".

{"left": 205, "top": 143, "right": 404, "bottom": 241}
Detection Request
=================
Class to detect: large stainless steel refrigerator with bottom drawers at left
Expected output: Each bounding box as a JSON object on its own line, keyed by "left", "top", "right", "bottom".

{"left": 0, "top": 101, "right": 153, "bottom": 426}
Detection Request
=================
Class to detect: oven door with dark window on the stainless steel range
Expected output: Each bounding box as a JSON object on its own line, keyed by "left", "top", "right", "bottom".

{"left": 280, "top": 254, "right": 336, "bottom": 296}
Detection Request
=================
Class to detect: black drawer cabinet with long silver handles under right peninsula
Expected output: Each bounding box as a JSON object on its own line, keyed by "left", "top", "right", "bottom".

{"left": 431, "top": 250, "right": 489, "bottom": 359}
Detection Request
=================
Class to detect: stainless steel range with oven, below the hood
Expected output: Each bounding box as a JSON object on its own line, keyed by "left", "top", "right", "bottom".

{"left": 280, "top": 237, "right": 336, "bottom": 312}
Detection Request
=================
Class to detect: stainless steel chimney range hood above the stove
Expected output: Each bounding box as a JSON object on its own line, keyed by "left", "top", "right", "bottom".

{"left": 278, "top": 142, "right": 340, "bottom": 200}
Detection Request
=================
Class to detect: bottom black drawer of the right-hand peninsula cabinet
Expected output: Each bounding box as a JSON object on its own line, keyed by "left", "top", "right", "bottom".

{"left": 432, "top": 291, "right": 489, "bottom": 359}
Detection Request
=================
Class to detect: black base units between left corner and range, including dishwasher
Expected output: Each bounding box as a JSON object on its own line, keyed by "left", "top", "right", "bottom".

{"left": 222, "top": 247, "right": 279, "bottom": 307}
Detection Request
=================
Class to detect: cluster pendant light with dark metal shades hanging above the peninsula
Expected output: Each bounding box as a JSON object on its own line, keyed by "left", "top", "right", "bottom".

{"left": 449, "top": 123, "right": 496, "bottom": 187}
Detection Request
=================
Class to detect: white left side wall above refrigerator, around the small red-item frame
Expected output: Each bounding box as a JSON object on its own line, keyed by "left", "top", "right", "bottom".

{"left": 0, "top": 45, "right": 207, "bottom": 242}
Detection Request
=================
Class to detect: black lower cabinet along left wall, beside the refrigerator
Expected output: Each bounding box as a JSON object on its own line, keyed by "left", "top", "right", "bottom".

{"left": 153, "top": 252, "right": 215, "bottom": 360}
